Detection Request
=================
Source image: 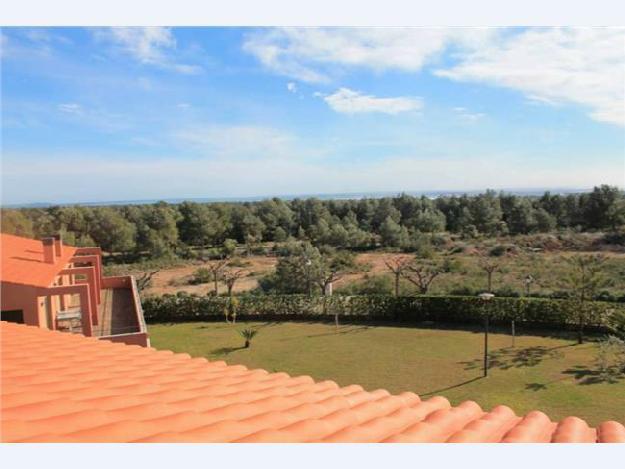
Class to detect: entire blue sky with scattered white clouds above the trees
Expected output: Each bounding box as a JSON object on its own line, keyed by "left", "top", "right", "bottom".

{"left": 2, "top": 28, "right": 625, "bottom": 204}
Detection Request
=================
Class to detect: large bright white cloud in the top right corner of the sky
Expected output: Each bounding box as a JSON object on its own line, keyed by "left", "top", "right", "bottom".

{"left": 436, "top": 28, "right": 625, "bottom": 125}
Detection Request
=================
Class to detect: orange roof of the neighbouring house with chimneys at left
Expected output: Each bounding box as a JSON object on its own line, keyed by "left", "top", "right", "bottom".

{"left": 0, "top": 233, "right": 76, "bottom": 287}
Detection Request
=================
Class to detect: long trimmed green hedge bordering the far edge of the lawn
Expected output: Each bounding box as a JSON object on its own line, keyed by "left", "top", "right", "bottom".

{"left": 143, "top": 295, "right": 625, "bottom": 329}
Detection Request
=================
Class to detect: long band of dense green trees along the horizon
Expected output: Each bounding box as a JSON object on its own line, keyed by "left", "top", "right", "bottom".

{"left": 2, "top": 185, "right": 625, "bottom": 258}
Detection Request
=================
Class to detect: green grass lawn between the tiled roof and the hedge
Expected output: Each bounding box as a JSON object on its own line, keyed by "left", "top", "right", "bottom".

{"left": 149, "top": 322, "right": 625, "bottom": 424}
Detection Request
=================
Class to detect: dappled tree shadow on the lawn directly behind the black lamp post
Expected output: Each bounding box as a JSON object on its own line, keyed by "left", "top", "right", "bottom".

{"left": 458, "top": 344, "right": 574, "bottom": 370}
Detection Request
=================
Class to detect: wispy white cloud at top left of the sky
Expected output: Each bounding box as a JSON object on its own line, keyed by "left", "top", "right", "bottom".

{"left": 95, "top": 26, "right": 202, "bottom": 74}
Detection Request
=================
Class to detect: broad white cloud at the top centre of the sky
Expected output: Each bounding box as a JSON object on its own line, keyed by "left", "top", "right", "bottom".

{"left": 243, "top": 28, "right": 497, "bottom": 82}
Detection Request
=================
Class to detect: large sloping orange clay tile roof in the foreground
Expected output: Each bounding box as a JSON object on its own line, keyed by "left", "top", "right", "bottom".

{"left": 0, "top": 322, "right": 625, "bottom": 442}
